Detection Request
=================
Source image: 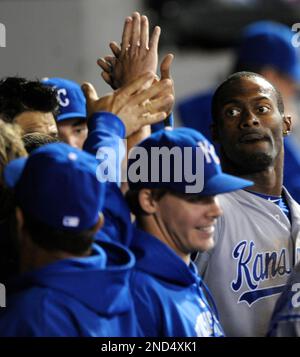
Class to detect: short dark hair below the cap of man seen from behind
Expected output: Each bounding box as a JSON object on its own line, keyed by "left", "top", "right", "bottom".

{"left": 23, "top": 210, "right": 97, "bottom": 255}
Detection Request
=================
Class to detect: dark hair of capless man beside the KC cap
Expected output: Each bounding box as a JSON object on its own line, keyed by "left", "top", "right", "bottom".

{"left": 0, "top": 77, "right": 59, "bottom": 122}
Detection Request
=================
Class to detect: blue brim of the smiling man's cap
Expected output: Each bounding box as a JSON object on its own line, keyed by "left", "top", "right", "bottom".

{"left": 200, "top": 173, "right": 254, "bottom": 196}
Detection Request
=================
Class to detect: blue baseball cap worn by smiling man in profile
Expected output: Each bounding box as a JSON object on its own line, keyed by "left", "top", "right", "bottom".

{"left": 127, "top": 128, "right": 253, "bottom": 196}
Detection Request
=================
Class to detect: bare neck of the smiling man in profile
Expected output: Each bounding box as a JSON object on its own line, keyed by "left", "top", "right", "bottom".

{"left": 137, "top": 215, "right": 191, "bottom": 265}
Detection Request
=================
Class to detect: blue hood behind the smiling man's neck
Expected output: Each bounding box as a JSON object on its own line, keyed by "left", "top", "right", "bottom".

{"left": 130, "top": 227, "right": 201, "bottom": 286}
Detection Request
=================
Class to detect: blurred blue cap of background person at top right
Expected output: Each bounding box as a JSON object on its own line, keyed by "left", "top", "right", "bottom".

{"left": 237, "top": 21, "right": 300, "bottom": 81}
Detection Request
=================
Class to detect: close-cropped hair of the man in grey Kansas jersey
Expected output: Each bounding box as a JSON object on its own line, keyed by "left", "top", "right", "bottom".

{"left": 211, "top": 71, "right": 284, "bottom": 123}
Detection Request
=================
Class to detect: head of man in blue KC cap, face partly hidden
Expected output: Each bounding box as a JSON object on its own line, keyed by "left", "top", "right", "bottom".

{"left": 42, "top": 78, "right": 88, "bottom": 149}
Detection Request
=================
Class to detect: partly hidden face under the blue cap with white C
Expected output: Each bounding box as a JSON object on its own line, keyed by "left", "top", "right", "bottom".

{"left": 57, "top": 118, "right": 88, "bottom": 149}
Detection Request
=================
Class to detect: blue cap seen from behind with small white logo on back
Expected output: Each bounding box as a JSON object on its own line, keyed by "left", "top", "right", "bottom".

{"left": 4, "top": 143, "right": 105, "bottom": 231}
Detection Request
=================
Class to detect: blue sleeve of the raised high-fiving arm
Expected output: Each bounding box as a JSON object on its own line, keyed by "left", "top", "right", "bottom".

{"left": 83, "top": 112, "right": 131, "bottom": 246}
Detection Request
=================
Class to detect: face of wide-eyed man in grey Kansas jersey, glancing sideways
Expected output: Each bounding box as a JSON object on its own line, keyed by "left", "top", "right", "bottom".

{"left": 216, "top": 77, "right": 284, "bottom": 173}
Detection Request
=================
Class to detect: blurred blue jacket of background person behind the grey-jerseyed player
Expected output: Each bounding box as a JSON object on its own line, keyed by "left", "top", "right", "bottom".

{"left": 177, "top": 91, "right": 300, "bottom": 203}
